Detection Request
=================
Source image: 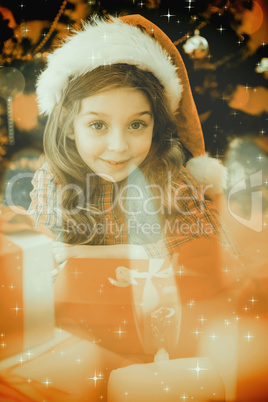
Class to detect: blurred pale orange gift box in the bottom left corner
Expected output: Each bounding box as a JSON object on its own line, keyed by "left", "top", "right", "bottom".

{"left": 0, "top": 329, "right": 127, "bottom": 402}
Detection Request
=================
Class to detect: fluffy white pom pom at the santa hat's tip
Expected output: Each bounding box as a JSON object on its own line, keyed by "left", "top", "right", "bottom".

{"left": 186, "top": 154, "right": 227, "bottom": 197}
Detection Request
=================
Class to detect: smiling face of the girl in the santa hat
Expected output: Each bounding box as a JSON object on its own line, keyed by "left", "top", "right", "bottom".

{"left": 71, "top": 88, "right": 154, "bottom": 182}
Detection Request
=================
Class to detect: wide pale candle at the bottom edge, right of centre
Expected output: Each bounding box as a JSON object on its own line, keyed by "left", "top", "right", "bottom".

{"left": 107, "top": 357, "right": 225, "bottom": 402}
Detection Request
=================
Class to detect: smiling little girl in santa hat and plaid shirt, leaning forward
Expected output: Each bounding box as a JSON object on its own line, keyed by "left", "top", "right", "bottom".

{"left": 29, "top": 15, "right": 237, "bottom": 262}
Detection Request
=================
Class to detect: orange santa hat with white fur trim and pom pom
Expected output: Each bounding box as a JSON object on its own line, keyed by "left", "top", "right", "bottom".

{"left": 37, "top": 15, "right": 225, "bottom": 193}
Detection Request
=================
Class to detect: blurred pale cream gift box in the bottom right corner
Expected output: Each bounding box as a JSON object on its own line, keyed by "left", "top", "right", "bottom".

{"left": 198, "top": 316, "right": 268, "bottom": 402}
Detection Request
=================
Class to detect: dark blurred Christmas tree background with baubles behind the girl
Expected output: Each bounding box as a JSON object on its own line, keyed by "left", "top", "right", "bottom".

{"left": 0, "top": 0, "right": 268, "bottom": 208}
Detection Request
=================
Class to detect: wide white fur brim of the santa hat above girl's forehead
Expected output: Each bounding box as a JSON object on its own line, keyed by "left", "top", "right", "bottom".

{"left": 36, "top": 17, "right": 182, "bottom": 115}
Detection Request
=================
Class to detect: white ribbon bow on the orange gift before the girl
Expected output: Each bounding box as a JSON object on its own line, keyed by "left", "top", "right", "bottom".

{"left": 108, "top": 259, "right": 173, "bottom": 314}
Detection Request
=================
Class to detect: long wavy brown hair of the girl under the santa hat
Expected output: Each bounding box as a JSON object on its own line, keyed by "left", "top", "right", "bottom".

{"left": 44, "top": 63, "right": 184, "bottom": 244}
